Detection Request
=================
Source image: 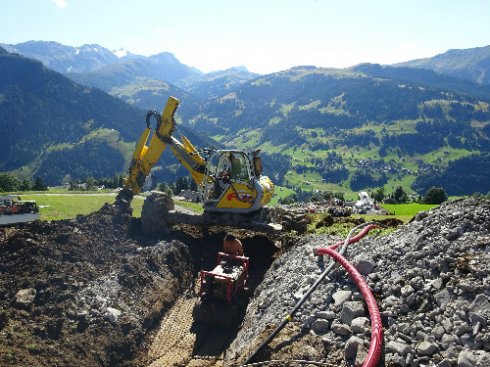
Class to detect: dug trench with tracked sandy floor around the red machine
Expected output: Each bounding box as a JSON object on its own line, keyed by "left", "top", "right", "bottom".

{"left": 133, "top": 226, "right": 279, "bottom": 367}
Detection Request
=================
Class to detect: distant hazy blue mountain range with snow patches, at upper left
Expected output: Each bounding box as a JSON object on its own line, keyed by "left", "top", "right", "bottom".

{"left": 0, "top": 41, "right": 258, "bottom": 109}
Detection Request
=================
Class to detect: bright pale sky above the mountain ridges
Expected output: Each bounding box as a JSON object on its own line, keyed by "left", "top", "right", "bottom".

{"left": 0, "top": 0, "right": 490, "bottom": 74}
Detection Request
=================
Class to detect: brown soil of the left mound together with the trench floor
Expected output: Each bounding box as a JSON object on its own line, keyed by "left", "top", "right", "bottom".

{"left": 0, "top": 204, "right": 281, "bottom": 366}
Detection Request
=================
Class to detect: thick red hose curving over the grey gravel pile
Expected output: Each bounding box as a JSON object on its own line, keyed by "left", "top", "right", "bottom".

{"left": 315, "top": 230, "right": 383, "bottom": 367}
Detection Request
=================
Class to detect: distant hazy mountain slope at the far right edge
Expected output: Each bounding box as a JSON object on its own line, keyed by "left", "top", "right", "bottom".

{"left": 396, "top": 45, "right": 490, "bottom": 85}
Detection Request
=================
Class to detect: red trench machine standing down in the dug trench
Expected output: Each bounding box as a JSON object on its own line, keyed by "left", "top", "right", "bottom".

{"left": 193, "top": 252, "right": 249, "bottom": 327}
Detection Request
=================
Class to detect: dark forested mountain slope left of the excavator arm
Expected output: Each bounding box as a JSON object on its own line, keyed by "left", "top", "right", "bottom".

{"left": 0, "top": 48, "right": 216, "bottom": 185}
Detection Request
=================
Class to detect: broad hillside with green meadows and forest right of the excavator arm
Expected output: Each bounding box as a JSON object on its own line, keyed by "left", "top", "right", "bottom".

{"left": 181, "top": 67, "right": 490, "bottom": 195}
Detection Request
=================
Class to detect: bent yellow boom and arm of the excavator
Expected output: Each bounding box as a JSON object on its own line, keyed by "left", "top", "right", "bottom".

{"left": 124, "top": 97, "right": 206, "bottom": 195}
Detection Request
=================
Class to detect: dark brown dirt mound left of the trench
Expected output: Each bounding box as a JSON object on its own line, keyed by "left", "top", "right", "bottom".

{"left": 0, "top": 204, "right": 193, "bottom": 366}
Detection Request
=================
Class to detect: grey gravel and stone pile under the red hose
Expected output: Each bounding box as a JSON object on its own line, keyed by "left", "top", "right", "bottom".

{"left": 230, "top": 199, "right": 490, "bottom": 367}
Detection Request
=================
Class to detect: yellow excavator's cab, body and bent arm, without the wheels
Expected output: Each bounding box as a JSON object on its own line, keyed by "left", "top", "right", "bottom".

{"left": 120, "top": 97, "right": 274, "bottom": 215}
